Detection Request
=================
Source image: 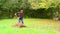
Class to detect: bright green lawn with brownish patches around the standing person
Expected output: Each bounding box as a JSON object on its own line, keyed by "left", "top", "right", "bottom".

{"left": 0, "top": 19, "right": 60, "bottom": 34}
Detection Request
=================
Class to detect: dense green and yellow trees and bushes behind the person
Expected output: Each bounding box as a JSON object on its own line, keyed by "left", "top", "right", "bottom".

{"left": 0, "top": 0, "right": 60, "bottom": 18}
